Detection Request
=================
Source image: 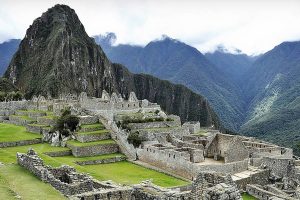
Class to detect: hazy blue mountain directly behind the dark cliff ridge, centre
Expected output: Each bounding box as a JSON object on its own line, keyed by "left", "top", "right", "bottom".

{"left": 96, "top": 33, "right": 245, "bottom": 130}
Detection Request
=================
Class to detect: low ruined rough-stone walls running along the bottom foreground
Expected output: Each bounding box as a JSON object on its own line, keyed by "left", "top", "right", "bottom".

{"left": 17, "top": 149, "right": 241, "bottom": 200}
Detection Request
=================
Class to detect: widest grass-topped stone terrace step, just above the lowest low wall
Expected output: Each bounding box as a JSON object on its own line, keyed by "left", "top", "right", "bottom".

{"left": 67, "top": 140, "right": 119, "bottom": 157}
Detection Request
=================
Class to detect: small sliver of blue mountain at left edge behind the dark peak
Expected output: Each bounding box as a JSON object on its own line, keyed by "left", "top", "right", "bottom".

{"left": 0, "top": 39, "right": 21, "bottom": 76}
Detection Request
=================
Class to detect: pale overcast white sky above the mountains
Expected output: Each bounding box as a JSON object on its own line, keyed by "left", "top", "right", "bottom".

{"left": 0, "top": 0, "right": 300, "bottom": 54}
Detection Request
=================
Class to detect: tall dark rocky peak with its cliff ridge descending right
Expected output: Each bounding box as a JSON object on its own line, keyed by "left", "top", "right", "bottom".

{"left": 5, "top": 5, "right": 219, "bottom": 127}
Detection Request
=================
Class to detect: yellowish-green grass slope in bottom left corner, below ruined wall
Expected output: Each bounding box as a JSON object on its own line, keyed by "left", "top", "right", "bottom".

{"left": 0, "top": 164, "right": 66, "bottom": 200}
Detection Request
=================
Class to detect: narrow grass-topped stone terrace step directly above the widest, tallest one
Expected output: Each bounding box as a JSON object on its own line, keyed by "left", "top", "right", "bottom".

{"left": 75, "top": 129, "right": 111, "bottom": 142}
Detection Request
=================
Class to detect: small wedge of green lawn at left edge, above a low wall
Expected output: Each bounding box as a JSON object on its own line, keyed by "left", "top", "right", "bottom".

{"left": 0, "top": 123, "right": 41, "bottom": 142}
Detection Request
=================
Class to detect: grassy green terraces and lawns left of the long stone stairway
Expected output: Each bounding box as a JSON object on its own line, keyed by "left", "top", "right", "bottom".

{"left": 0, "top": 110, "right": 188, "bottom": 199}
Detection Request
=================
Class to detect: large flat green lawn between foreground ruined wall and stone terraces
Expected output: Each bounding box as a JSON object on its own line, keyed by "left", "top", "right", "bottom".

{"left": 0, "top": 144, "right": 188, "bottom": 187}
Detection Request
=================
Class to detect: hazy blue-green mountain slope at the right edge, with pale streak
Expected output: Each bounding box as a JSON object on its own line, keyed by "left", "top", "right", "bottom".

{"left": 241, "top": 42, "right": 300, "bottom": 155}
